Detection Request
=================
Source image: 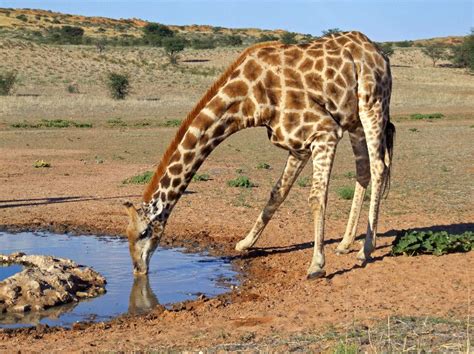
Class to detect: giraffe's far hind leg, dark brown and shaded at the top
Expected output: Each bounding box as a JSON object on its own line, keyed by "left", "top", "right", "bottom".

{"left": 336, "top": 126, "right": 370, "bottom": 254}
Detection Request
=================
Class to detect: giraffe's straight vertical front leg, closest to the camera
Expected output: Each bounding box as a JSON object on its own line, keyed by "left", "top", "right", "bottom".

{"left": 307, "top": 136, "right": 338, "bottom": 279}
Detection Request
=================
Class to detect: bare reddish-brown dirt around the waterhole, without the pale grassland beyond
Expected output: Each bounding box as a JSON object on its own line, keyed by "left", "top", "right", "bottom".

{"left": 0, "top": 119, "right": 474, "bottom": 352}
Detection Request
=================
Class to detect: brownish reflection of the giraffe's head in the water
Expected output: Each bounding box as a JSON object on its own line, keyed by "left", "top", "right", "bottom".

{"left": 128, "top": 275, "right": 159, "bottom": 315}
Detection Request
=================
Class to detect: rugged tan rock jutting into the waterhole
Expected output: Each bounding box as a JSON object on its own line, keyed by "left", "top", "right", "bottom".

{"left": 0, "top": 252, "right": 106, "bottom": 322}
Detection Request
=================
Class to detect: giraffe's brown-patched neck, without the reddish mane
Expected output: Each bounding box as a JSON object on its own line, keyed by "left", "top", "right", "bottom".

{"left": 145, "top": 96, "right": 251, "bottom": 223}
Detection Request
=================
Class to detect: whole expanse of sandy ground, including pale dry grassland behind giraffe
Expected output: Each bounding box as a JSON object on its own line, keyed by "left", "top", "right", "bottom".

{"left": 0, "top": 36, "right": 474, "bottom": 352}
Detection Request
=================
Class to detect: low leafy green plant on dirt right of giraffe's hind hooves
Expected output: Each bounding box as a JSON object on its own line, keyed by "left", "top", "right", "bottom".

{"left": 391, "top": 230, "right": 474, "bottom": 256}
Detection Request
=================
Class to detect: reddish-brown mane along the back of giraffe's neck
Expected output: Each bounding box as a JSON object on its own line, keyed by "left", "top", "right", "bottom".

{"left": 143, "top": 41, "right": 279, "bottom": 203}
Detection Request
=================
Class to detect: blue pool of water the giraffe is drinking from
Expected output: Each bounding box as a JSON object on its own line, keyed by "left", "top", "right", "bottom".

{"left": 0, "top": 232, "right": 237, "bottom": 327}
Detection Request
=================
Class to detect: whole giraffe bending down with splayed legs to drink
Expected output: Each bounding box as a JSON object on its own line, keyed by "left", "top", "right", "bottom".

{"left": 125, "top": 31, "right": 395, "bottom": 279}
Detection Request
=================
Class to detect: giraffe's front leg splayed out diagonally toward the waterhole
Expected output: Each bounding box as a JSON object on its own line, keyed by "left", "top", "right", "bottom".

{"left": 235, "top": 154, "right": 308, "bottom": 251}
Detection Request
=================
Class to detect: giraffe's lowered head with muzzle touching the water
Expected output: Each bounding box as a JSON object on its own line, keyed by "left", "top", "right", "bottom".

{"left": 124, "top": 202, "right": 164, "bottom": 275}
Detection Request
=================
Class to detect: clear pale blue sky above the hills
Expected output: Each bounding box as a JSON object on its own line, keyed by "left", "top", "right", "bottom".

{"left": 0, "top": 0, "right": 474, "bottom": 41}
